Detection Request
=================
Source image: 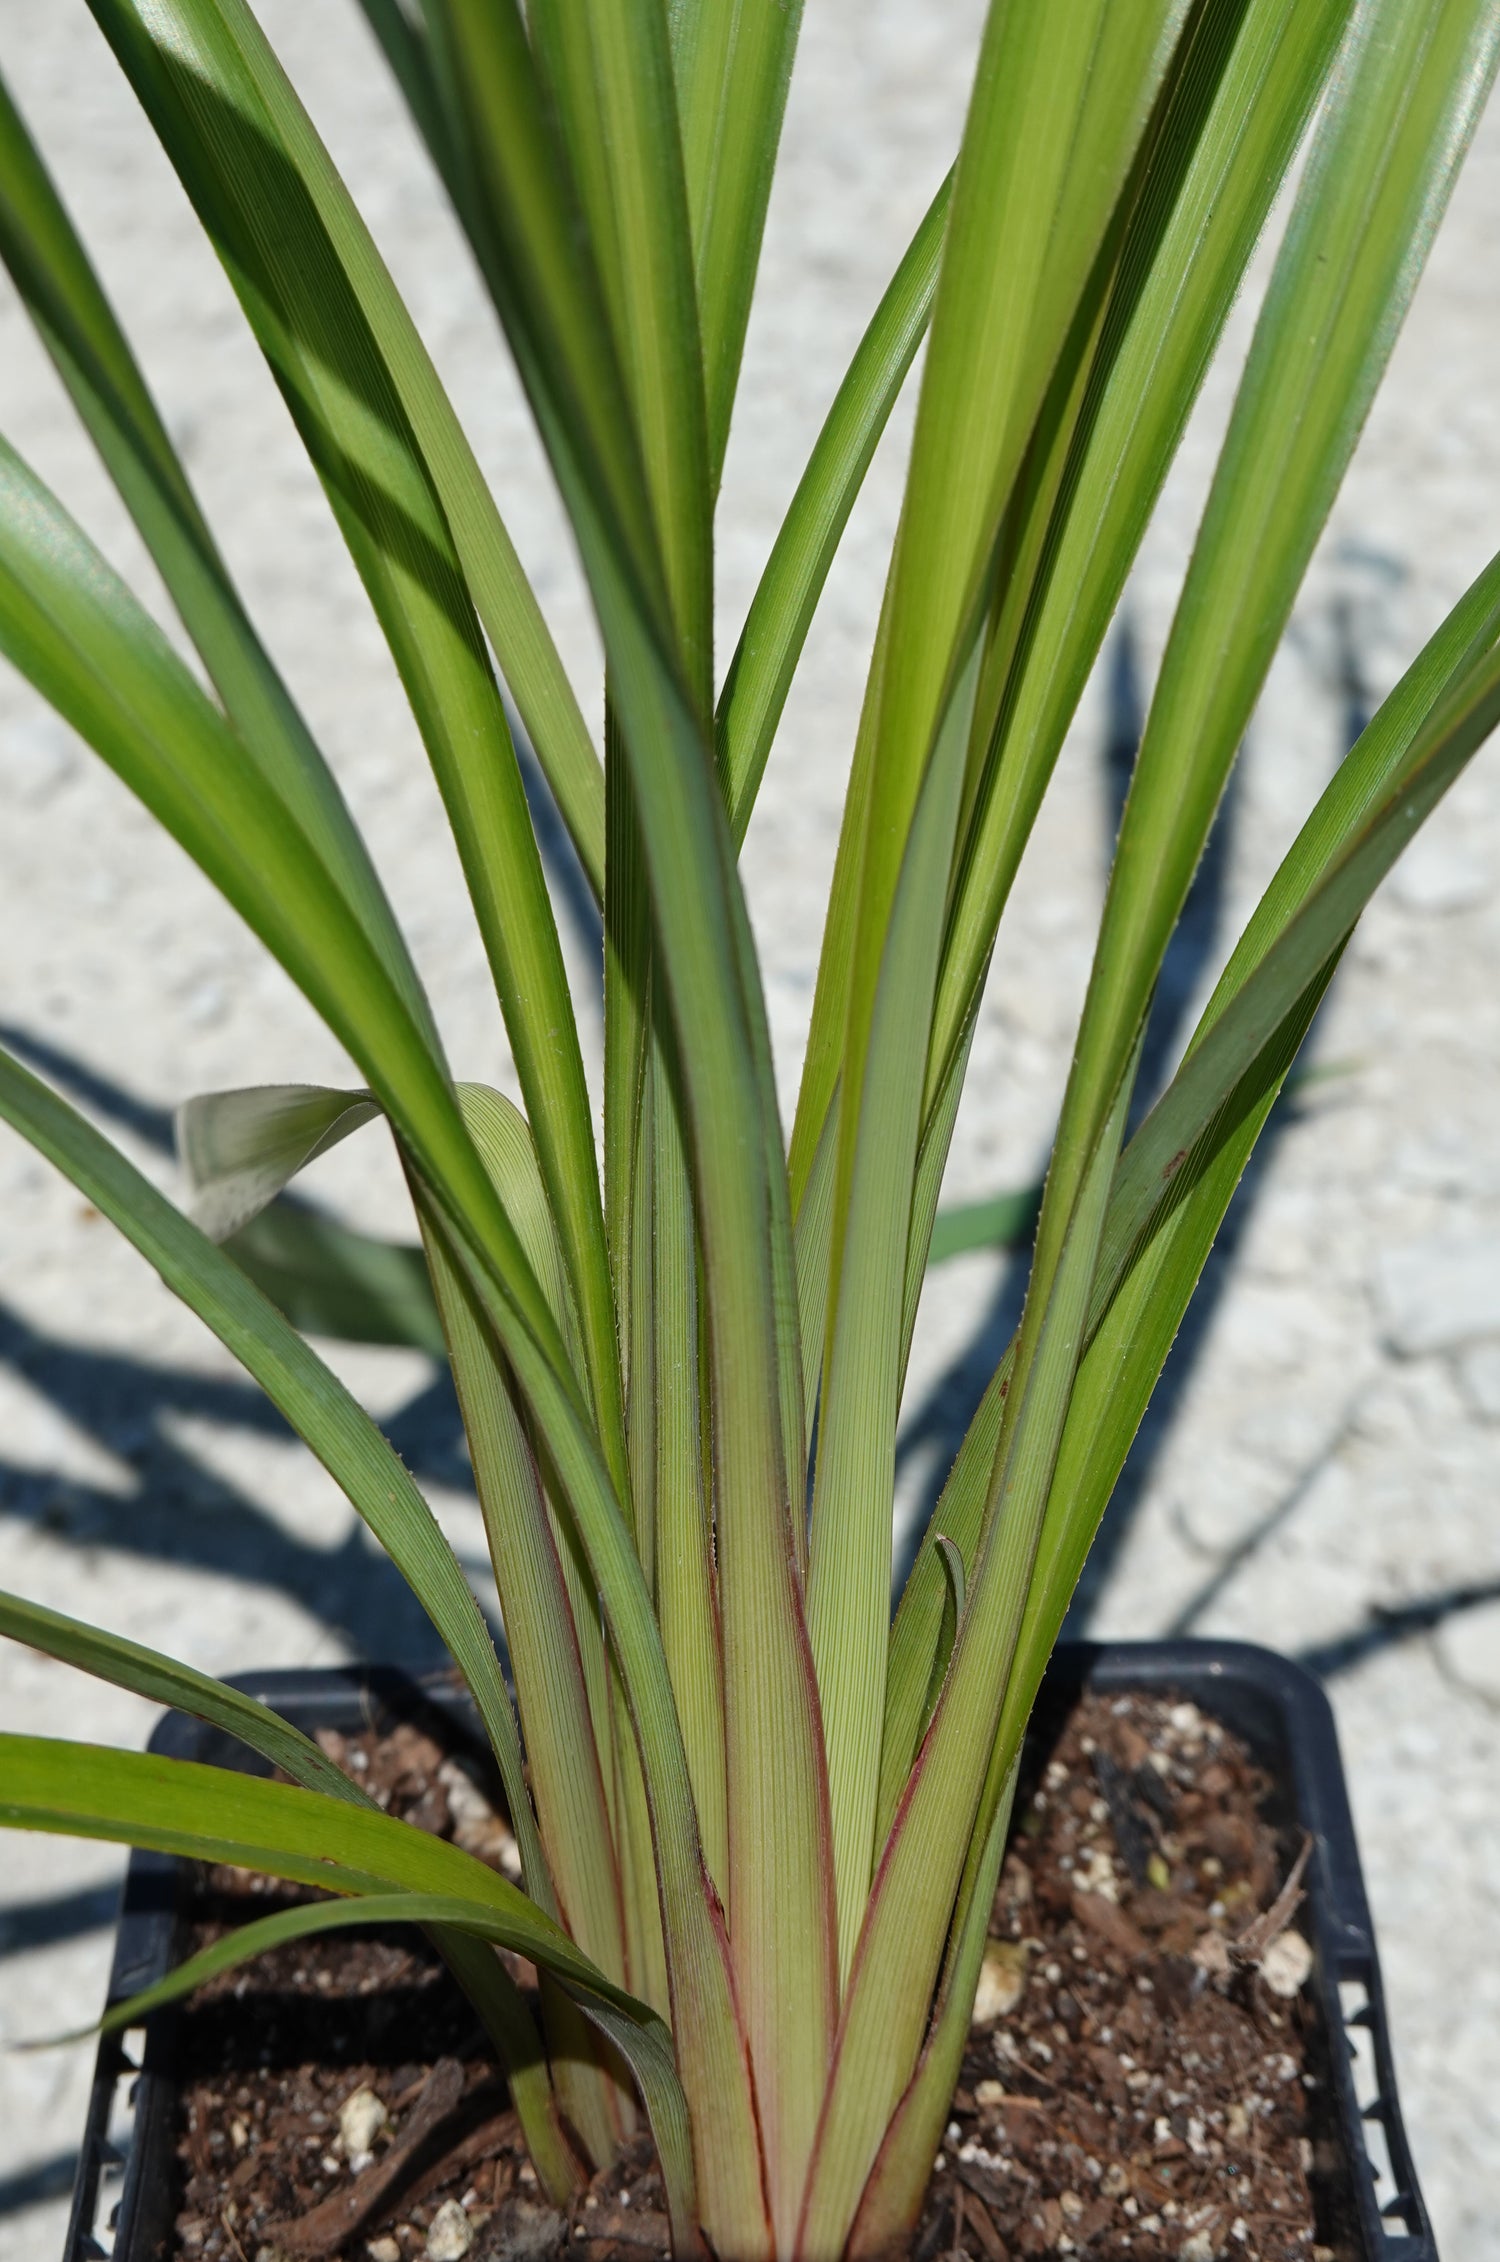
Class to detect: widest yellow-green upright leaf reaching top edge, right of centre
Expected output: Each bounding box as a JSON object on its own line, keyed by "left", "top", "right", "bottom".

{"left": 835, "top": 0, "right": 1183, "bottom": 1203}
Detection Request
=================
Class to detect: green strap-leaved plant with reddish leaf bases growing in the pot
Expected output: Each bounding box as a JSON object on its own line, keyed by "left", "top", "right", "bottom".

{"left": 0, "top": 0, "right": 1500, "bottom": 2262}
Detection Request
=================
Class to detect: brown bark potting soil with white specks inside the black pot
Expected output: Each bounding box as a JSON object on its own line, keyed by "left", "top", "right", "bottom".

{"left": 161, "top": 1697, "right": 1355, "bottom": 2262}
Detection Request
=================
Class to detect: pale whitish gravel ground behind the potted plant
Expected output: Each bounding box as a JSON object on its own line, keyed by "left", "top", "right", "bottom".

{"left": 0, "top": 0, "right": 1500, "bottom": 2262}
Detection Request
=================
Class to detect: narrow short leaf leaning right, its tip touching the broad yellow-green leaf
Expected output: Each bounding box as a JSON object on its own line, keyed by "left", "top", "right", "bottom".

{"left": 717, "top": 179, "right": 952, "bottom": 848}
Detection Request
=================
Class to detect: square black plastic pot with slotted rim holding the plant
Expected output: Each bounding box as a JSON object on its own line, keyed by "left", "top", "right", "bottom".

{"left": 63, "top": 1642, "right": 1437, "bottom": 2262}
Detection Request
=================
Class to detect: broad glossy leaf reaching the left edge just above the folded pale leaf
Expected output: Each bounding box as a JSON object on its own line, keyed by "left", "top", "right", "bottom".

{"left": 0, "top": 427, "right": 647, "bottom": 1782}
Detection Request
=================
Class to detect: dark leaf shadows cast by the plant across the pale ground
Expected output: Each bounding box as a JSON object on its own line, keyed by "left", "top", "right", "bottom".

{"left": 0, "top": 595, "right": 1500, "bottom": 2221}
